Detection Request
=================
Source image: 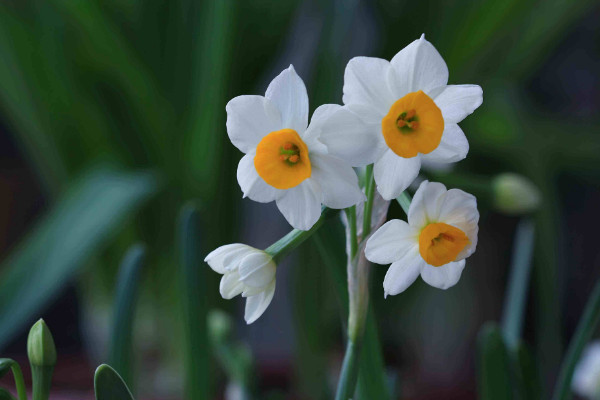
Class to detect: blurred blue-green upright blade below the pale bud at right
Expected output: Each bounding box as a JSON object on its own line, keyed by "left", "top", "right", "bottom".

{"left": 502, "top": 219, "right": 535, "bottom": 349}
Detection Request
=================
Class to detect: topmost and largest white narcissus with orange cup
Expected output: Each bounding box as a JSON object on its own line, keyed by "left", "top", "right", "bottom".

{"left": 321, "top": 35, "right": 483, "bottom": 200}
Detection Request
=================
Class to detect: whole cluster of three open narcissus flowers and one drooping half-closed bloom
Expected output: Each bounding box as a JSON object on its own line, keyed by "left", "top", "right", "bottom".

{"left": 206, "top": 36, "right": 483, "bottom": 323}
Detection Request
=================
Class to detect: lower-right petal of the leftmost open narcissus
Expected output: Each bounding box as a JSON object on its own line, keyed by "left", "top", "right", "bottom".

{"left": 310, "top": 154, "right": 365, "bottom": 208}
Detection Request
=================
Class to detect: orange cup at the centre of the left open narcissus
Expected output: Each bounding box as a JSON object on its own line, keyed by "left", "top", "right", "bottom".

{"left": 254, "top": 129, "right": 311, "bottom": 189}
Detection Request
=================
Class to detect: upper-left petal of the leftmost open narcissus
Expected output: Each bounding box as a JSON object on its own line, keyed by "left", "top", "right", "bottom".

{"left": 225, "top": 96, "right": 282, "bottom": 153}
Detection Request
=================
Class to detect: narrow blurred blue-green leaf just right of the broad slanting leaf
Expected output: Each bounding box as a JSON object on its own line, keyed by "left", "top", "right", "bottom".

{"left": 108, "top": 244, "right": 146, "bottom": 385}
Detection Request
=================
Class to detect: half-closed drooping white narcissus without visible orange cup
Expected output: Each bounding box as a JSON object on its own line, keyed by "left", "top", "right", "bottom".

{"left": 204, "top": 243, "right": 277, "bottom": 324}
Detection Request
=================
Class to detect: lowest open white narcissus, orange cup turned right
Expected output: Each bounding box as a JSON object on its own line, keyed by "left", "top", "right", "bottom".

{"left": 365, "top": 181, "right": 479, "bottom": 296}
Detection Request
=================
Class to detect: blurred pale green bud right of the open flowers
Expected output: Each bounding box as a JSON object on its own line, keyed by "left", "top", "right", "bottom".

{"left": 492, "top": 173, "right": 541, "bottom": 215}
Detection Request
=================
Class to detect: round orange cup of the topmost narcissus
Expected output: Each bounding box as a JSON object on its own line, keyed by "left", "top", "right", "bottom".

{"left": 381, "top": 90, "right": 444, "bottom": 158}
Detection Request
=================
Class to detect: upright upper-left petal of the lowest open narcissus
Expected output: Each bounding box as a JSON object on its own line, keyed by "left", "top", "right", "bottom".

{"left": 408, "top": 181, "right": 446, "bottom": 229}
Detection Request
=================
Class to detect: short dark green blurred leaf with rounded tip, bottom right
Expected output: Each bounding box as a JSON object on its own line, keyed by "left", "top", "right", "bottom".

{"left": 477, "top": 323, "right": 513, "bottom": 400}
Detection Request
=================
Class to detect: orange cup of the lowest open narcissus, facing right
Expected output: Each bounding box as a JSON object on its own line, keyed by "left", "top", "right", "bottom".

{"left": 419, "top": 222, "right": 470, "bottom": 267}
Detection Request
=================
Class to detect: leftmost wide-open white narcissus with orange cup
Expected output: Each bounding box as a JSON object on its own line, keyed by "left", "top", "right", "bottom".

{"left": 225, "top": 65, "right": 364, "bottom": 230}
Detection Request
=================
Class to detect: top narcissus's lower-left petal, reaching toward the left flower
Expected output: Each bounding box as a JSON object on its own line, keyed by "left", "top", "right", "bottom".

{"left": 320, "top": 107, "right": 386, "bottom": 167}
